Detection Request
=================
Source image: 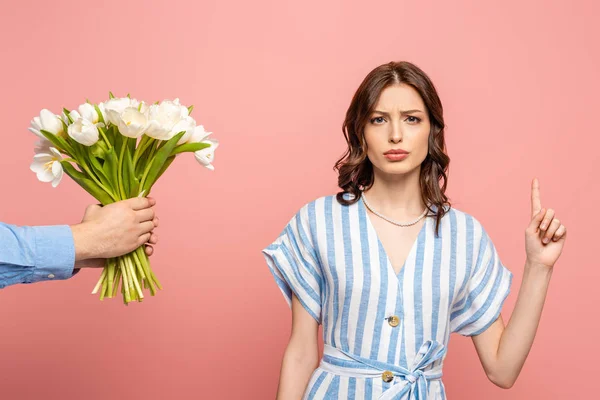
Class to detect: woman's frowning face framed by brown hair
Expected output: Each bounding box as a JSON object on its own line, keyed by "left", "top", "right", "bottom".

{"left": 364, "top": 84, "right": 430, "bottom": 175}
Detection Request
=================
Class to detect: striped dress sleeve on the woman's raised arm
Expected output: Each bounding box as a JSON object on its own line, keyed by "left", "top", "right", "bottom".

{"left": 450, "top": 224, "right": 513, "bottom": 336}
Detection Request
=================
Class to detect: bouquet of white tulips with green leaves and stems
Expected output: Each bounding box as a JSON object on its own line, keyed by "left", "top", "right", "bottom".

{"left": 29, "top": 93, "right": 218, "bottom": 304}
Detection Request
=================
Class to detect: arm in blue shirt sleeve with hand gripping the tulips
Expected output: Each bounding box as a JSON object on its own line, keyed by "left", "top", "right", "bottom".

{"left": 0, "top": 197, "right": 158, "bottom": 289}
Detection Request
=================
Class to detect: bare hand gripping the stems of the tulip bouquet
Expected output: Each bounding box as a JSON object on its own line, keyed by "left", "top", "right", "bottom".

{"left": 71, "top": 197, "right": 158, "bottom": 267}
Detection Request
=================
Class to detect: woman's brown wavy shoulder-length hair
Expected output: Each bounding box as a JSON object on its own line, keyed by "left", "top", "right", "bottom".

{"left": 334, "top": 61, "right": 451, "bottom": 233}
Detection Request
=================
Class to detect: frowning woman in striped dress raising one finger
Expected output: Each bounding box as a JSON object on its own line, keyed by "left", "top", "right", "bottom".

{"left": 263, "top": 62, "right": 566, "bottom": 400}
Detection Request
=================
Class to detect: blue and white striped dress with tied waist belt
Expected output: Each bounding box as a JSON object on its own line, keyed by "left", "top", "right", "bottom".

{"left": 262, "top": 193, "right": 513, "bottom": 400}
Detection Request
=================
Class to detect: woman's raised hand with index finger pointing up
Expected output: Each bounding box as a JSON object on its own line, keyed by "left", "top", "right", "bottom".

{"left": 525, "top": 178, "right": 567, "bottom": 268}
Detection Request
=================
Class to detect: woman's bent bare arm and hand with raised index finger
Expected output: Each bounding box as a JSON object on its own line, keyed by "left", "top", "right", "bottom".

{"left": 473, "top": 179, "right": 567, "bottom": 388}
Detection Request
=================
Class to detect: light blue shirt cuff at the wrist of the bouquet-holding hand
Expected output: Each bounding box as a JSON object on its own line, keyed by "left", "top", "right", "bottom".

{"left": 31, "top": 225, "right": 75, "bottom": 283}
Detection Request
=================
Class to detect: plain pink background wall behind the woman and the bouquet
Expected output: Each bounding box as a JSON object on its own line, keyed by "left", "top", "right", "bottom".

{"left": 0, "top": 0, "right": 600, "bottom": 399}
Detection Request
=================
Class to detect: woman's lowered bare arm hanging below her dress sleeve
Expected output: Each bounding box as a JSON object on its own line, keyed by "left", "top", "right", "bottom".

{"left": 277, "top": 293, "right": 319, "bottom": 400}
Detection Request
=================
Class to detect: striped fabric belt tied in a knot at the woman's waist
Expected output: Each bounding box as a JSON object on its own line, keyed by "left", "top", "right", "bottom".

{"left": 319, "top": 340, "right": 447, "bottom": 400}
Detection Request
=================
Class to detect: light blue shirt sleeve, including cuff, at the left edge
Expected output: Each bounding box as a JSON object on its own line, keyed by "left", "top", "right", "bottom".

{"left": 0, "top": 222, "right": 79, "bottom": 289}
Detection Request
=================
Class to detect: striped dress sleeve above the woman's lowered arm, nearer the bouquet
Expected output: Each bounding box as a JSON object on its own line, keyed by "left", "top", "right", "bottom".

{"left": 262, "top": 208, "right": 323, "bottom": 324}
